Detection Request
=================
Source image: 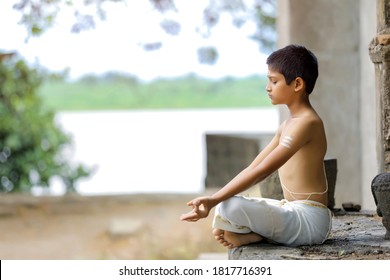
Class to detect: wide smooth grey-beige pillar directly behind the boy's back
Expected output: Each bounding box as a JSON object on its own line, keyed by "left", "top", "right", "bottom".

{"left": 277, "top": 0, "right": 364, "bottom": 207}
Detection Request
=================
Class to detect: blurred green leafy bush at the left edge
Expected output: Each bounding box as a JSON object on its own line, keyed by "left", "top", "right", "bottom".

{"left": 0, "top": 53, "right": 89, "bottom": 192}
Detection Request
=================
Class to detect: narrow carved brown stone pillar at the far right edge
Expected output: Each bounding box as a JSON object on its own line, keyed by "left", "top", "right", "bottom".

{"left": 369, "top": 0, "right": 390, "bottom": 172}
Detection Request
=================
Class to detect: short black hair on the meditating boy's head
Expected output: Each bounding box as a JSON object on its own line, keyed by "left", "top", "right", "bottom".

{"left": 267, "top": 45, "right": 318, "bottom": 94}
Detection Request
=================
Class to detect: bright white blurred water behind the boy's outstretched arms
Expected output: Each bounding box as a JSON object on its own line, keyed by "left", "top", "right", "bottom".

{"left": 44, "top": 108, "right": 279, "bottom": 195}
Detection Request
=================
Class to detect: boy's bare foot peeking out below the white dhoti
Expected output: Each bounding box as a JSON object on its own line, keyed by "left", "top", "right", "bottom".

{"left": 213, "top": 229, "right": 263, "bottom": 249}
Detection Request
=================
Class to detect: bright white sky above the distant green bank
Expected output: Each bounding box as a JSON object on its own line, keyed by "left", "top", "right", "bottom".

{"left": 0, "top": 0, "right": 267, "bottom": 81}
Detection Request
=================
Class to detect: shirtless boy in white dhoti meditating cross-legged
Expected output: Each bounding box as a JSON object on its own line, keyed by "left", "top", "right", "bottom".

{"left": 181, "top": 45, "right": 332, "bottom": 249}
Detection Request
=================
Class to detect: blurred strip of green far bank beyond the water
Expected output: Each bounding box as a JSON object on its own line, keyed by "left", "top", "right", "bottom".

{"left": 39, "top": 76, "right": 271, "bottom": 111}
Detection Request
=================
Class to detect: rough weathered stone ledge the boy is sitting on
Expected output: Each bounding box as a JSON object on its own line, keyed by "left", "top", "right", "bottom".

{"left": 229, "top": 211, "right": 390, "bottom": 260}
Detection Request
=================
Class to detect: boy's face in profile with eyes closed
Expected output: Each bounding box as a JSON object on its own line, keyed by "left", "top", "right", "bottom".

{"left": 265, "top": 67, "right": 294, "bottom": 105}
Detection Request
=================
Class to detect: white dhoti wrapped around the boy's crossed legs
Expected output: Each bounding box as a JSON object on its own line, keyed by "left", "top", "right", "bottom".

{"left": 213, "top": 196, "right": 332, "bottom": 246}
